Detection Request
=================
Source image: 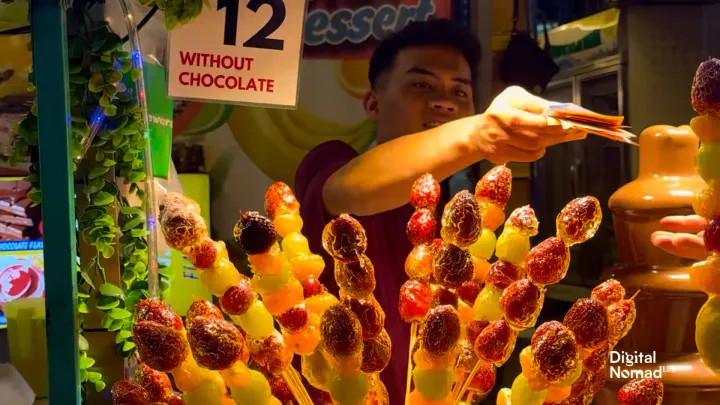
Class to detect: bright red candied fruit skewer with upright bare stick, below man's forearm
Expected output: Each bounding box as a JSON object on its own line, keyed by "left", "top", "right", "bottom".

{"left": 398, "top": 173, "right": 440, "bottom": 398}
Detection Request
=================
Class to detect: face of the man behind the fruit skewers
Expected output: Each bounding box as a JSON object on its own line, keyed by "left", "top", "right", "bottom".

{"left": 365, "top": 46, "right": 475, "bottom": 143}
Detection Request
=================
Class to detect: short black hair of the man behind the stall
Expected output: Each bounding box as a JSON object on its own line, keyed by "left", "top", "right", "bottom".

{"left": 368, "top": 19, "right": 481, "bottom": 88}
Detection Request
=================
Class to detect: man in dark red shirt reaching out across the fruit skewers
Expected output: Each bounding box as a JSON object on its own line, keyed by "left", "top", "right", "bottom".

{"left": 295, "top": 20, "right": 584, "bottom": 405}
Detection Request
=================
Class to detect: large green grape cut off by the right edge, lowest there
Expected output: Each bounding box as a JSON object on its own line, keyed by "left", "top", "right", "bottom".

{"left": 695, "top": 295, "right": 720, "bottom": 374}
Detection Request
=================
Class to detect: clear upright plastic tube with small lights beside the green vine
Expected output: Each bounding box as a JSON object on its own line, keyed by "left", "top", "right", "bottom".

{"left": 120, "top": 0, "right": 159, "bottom": 299}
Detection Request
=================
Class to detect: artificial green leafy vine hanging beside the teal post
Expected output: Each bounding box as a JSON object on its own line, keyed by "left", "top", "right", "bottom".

{"left": 7, "top": 1, "right": 175, "bottom": 391}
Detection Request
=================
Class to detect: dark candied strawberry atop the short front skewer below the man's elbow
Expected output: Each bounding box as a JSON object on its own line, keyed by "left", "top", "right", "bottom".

{"left": 320, "top": 304, "right": 363, "bottom": 357}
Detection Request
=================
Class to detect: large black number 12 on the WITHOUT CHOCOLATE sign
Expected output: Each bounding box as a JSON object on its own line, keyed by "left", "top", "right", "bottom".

{"left": 218, "top": 0, "right": 286, "bottom": 51}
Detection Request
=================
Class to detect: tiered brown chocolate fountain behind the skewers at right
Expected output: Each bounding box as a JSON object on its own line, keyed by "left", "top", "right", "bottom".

{"left": 595, "top": 125, "right": 720, "bottom": 405}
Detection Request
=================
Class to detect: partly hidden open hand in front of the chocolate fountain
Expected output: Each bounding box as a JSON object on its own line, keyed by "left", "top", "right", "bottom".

{"left": 650, "top": 215, "right": 707, "bottom": 260}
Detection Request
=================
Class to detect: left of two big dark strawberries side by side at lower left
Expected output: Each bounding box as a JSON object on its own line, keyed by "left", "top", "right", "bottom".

{"left": 132, "top": 321, "right": 190, "bottom": 371}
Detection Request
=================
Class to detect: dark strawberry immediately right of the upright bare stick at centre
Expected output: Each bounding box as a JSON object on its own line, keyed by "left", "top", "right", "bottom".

{"left": 420, "top": 305, "right": 461, "bottom": 356}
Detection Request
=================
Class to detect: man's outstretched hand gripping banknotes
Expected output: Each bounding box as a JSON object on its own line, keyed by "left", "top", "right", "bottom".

{"left": 471, "top": 86, "right": 587, "bottom": 164}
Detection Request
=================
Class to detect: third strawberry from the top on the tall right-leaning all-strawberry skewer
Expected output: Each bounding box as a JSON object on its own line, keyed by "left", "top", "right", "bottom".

{"left": 500, "top": 278, "right": 545, "bottom": 329}
